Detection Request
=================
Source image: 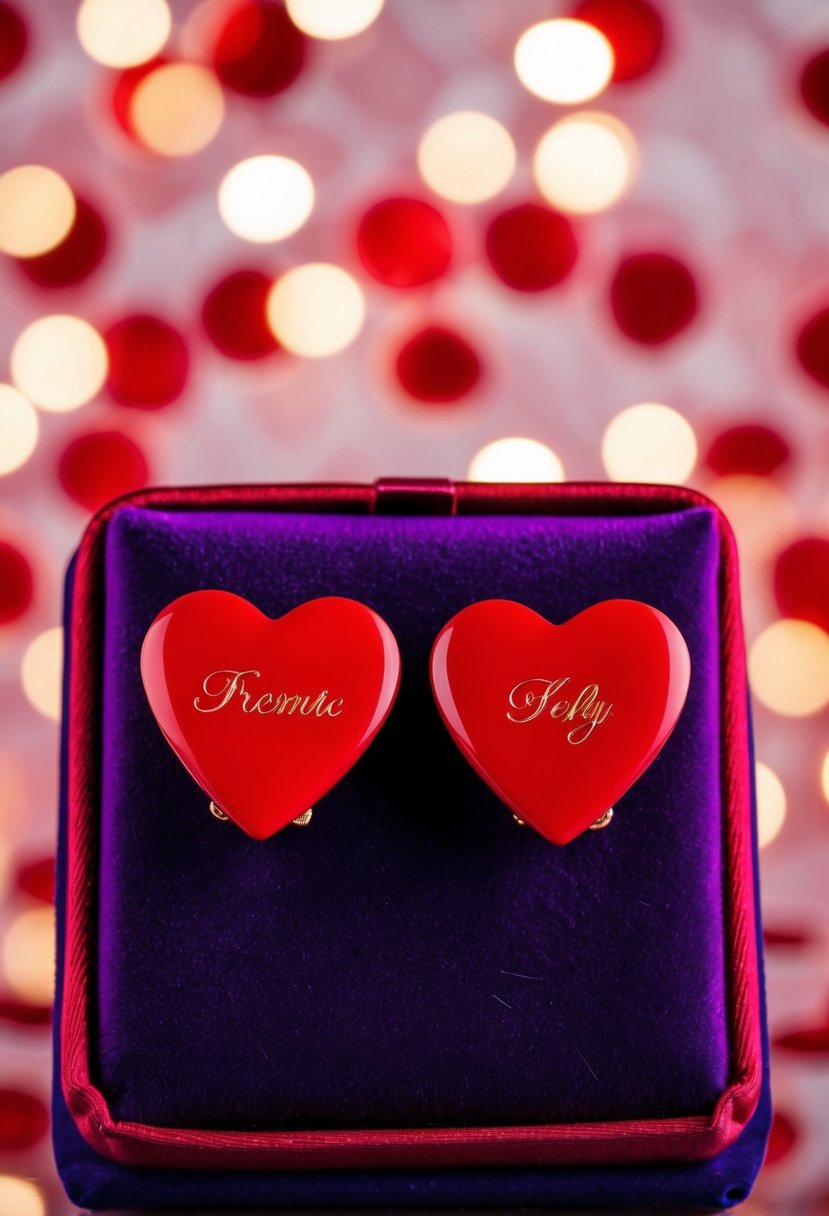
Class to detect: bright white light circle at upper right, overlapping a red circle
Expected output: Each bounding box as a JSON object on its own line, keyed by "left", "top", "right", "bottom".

{"left": 515, "top": 17, "right": 614, "bottom": 106}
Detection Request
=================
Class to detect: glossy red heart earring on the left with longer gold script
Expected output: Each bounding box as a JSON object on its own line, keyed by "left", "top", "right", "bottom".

{"left": 141, "top": 591, "right": 400, "bottom": 840}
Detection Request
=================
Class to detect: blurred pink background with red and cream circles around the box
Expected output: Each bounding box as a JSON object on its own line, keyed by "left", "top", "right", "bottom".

{"left": 0, "top": 0, "right": 829, "bottom": 1216}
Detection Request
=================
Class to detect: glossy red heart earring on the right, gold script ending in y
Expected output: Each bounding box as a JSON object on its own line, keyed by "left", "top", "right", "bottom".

{"left": 430, "top": 599, "right": 690, "bottom": 844}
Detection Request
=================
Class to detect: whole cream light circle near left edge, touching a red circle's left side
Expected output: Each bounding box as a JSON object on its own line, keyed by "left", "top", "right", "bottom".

{"left": 11, "top": 314, "right": 108, "bottom": 413}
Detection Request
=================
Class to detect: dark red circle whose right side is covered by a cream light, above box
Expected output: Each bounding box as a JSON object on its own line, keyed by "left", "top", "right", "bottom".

{"left": 202, "top": 270, "right": 278, "bottom": 360}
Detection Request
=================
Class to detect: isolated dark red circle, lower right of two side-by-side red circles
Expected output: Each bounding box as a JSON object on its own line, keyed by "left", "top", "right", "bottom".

{"left": 610, "top": 252, "right": 698, "bottom": 347}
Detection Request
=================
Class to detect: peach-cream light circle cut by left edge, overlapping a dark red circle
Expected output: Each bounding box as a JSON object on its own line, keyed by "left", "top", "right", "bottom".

{"left": 0, "top": 164, "right": 75, "bottom": 258}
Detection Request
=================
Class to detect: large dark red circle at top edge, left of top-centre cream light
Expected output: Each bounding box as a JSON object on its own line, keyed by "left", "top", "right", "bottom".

{"left": 210, "top": 0, "right": 305, "bottom": 97}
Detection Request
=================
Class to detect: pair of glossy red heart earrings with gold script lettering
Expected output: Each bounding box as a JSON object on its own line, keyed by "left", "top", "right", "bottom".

{"left": 141, "top": 591, "right": 690, "bottom": 845}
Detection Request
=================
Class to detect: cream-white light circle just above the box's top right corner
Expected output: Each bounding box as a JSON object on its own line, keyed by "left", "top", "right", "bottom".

{"left": 602, "top": 401, "right": 697, "bottom": 485}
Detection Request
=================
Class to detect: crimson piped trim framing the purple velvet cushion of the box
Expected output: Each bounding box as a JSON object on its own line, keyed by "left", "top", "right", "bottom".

{"left": 60, "top": 479, "right": 762, "bottom": 1170}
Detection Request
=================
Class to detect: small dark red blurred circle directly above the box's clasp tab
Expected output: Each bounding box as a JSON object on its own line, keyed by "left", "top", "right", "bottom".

{"left": 395, "top": 325, "right": 483, "bottom": 405}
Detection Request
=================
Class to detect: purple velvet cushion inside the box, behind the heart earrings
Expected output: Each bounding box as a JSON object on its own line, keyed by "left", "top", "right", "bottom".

{"left": 96, "top": 508, "right": 728, "bottom": 1128}
